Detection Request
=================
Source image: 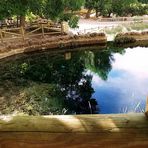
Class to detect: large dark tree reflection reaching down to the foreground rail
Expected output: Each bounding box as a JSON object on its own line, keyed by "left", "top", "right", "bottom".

{"left": 17, "top": 53, "right": 97, "bottom": 114}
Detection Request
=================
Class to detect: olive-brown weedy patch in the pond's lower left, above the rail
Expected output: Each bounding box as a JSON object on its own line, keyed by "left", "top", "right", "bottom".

{"left": 0, "top": 81, "right": 66, "bottom": 115}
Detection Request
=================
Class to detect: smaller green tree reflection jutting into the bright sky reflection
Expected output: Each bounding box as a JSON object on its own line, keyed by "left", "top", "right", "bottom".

{"left": 82, "top": 43, "right": 125, "bottom": 80}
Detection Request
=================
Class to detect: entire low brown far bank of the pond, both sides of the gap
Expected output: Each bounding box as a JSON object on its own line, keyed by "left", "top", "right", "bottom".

{"left": 0, "top": 31, "right": 148, "bottom": 60}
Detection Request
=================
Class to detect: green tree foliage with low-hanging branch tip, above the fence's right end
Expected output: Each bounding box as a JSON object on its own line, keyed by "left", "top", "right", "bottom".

{"left": 43, "top": 0, "right": 84, "bottom": 27}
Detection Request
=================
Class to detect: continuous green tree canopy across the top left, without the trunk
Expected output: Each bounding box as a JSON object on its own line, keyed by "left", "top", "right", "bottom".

{"left": 0, "top": 0, "right": 84, "bottom": 26}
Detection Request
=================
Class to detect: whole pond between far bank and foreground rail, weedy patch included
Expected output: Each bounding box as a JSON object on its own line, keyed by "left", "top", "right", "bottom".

{"left": 0, "top": 47, "right": 148, "bottom": 115}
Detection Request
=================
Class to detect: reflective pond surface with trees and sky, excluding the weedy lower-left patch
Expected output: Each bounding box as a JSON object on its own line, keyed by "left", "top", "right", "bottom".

{"left": 0, "top": 47, "right": 148, "bottom": 114}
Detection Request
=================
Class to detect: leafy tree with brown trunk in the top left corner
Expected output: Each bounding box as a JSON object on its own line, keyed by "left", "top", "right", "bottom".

{"left": 0, "top": 0, "right": 43, "bottom": 26}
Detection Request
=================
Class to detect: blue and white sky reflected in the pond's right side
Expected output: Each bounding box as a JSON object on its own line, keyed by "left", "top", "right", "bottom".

{"left": 92, "top": 47, "right": 148, "bottom": 113}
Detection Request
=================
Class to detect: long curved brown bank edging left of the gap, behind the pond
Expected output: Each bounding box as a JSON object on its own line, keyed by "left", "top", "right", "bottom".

{"left": 0, "top": 33, "right": 107, "bottom": 59}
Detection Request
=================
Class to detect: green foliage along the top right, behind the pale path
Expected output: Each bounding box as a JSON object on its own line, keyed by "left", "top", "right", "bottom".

{"left": 85, "top": 0, "right": 148, "bottom": 16}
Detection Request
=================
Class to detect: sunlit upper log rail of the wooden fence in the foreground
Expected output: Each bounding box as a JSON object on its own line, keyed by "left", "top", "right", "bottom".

{"left": 0, "top": 114, "right": 148, "bottom": 133}
